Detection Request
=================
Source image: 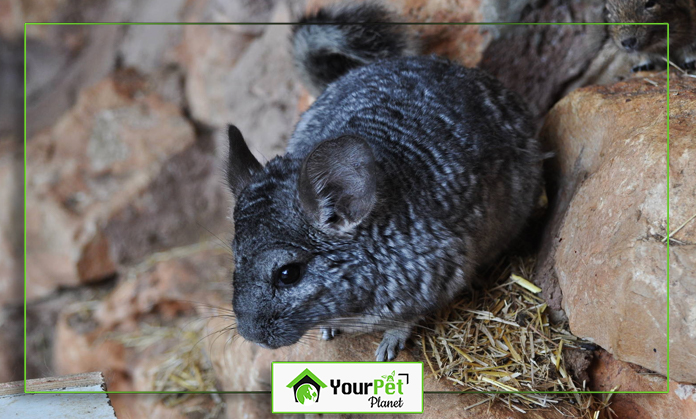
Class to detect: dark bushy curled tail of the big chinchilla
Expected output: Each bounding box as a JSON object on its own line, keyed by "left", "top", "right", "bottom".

{"left": 292, "top": 2, "right": 419, "bottom": 96}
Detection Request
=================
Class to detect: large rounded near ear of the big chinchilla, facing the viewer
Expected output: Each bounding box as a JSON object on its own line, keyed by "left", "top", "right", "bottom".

{"left": 298, "top": 135, "right": 377, "bottom": 232}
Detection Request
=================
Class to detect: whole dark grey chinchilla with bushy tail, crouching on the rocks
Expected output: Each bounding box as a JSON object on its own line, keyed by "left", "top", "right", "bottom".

{"left": 227, "top": 4, "right": 542, "bottom": 360}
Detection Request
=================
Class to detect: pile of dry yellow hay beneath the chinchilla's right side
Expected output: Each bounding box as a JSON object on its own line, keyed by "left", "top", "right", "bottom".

{"left": 416, "top": 259, "right": 612, "bottom": 419}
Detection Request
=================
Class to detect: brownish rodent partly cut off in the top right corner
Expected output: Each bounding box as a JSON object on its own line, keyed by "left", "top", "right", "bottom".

{"left": 606, "top": 0, "right": 696, "bottom": 71}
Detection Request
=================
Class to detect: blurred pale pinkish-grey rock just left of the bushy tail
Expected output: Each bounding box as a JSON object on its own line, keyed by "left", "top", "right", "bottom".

{"left": 183, "top": 3, "right": 299, "bottom": 161}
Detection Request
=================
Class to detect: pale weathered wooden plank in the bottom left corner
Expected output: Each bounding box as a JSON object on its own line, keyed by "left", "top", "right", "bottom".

{"left": 0, "top": 372, "right": 116, "bottom": 419}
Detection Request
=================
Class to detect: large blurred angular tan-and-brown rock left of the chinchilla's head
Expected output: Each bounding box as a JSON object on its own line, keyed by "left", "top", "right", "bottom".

{"left": 27, "top": 78, "right": 228, "bottom": 300}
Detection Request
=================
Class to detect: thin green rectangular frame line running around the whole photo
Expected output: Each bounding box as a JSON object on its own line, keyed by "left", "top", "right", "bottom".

{"left": 23, "top": 22, "right": 670, "bottom": 394}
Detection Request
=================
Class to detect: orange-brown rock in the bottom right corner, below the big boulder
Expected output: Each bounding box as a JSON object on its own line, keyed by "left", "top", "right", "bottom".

{"left": 590, "top": 351, "right": 696, "bottom": 419}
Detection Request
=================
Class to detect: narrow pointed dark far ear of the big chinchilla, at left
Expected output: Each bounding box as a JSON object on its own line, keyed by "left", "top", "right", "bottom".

{"left": 221, "top": 125, "right": 263, "bottom": 197}
